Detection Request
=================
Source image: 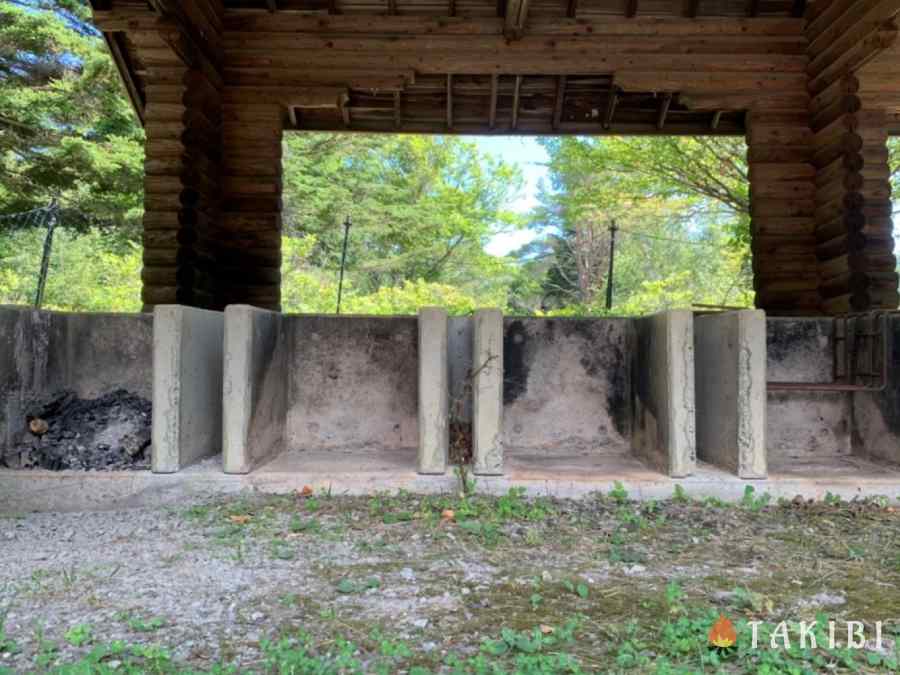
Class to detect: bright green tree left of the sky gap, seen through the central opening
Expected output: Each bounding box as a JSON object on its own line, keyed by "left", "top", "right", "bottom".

{"left": 284, "top": 134, "right": 521, "bottom": 304}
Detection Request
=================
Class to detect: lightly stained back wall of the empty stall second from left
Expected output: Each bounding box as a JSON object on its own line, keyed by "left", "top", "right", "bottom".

{"left": 284, "top": 315, "right": 418, "bottom": 450}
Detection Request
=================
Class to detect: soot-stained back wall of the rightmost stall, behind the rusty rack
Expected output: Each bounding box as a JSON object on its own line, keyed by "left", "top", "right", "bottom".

{"left": 766, "top": 318, "right": 852, "bottom": 464}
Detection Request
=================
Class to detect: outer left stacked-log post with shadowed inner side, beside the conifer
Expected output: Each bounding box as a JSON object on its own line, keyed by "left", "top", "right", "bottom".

{"left": 137, "top": 3, "right": 222, "bottom": 311}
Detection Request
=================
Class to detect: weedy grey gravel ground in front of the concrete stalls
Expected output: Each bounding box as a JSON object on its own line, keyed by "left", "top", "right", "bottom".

{"left": 0, "top": 488, "right": 900, "bottom": 672}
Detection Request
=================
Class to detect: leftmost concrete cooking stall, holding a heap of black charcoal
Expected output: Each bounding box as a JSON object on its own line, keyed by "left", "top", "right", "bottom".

{"left": 0, "top": 305, "right": 223, "bottom": 473}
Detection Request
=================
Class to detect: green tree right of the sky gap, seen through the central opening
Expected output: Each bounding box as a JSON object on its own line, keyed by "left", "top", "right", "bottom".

{"left": 515, "top": 138, "right": 752, "bottom": 313}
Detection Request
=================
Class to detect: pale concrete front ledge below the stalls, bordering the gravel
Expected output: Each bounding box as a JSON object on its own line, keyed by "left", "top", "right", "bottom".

{"left": 0, "top": 459, "right": 900, "bottom": 514}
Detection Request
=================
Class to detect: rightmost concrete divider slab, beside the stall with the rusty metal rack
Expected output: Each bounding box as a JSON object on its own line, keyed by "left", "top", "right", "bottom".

{"left": 694, "top": 310, "right": 767, "bottom": 478}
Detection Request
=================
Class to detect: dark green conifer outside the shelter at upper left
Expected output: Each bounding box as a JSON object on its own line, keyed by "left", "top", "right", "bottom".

{"left": 0, "top": 0, "right": 144, "bottom": 236}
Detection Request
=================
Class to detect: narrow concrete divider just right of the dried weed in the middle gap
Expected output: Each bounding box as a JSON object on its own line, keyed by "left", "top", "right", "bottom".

{"left": 472, "top": 309, "right": 503, "bottom": 476}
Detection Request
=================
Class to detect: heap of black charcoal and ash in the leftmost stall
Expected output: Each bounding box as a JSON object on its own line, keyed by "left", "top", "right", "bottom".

{"left": 0, "top": 389, "right": 152, "bottom": 471}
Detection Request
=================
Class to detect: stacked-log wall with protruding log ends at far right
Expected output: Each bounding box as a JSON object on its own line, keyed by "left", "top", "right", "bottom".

{"left": 806, "top": 0, "right": 900, "bottom": 314}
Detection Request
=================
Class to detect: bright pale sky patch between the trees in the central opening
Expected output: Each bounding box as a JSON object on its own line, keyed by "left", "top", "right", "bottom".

{"left": 472, "top": 136, "right": 549, "bottom": 256}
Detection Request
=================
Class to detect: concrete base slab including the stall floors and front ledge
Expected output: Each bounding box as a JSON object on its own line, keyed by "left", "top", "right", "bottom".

{"left": 0, "top": 449, "right": 900, "bottom": 513}
